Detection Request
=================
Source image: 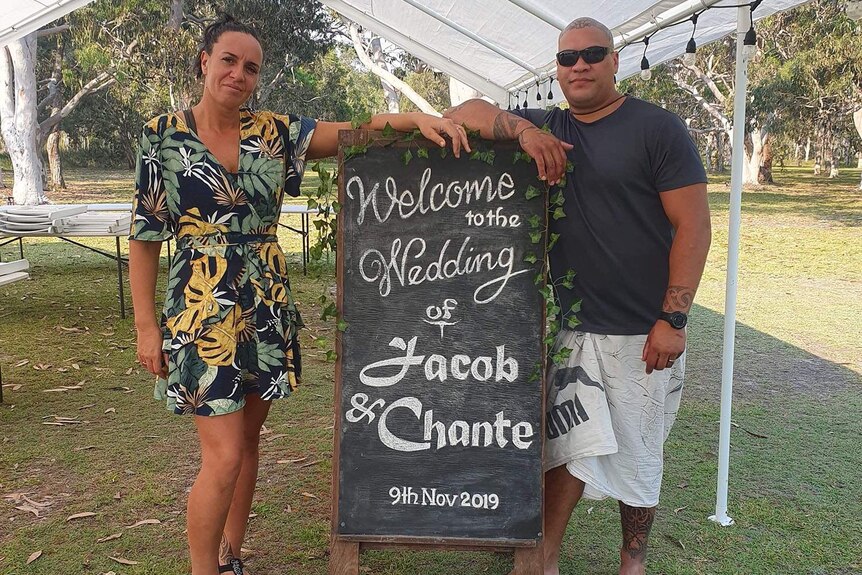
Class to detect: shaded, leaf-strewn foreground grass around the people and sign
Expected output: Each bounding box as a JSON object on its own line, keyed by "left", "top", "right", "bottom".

{"left": 0, "top": 249, "right": 862, "bottom": 575}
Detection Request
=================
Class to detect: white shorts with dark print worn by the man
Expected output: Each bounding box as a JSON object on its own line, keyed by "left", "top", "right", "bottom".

{"left": 545, "top": 330, "right": 685, "bottom": 507}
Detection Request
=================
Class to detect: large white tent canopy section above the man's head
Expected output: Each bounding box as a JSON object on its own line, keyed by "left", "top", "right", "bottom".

{"left": 321, "top": 0, "right": 804, "bottom": 105}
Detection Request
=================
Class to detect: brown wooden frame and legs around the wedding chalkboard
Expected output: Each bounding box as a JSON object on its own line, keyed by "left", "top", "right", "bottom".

{"left": 329, "top": 130, "right": 548, "bottom": 575}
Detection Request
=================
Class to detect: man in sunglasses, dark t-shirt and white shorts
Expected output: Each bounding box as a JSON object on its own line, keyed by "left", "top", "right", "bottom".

{"left": 445, "top": 18, "right": 710, "bottom": 575}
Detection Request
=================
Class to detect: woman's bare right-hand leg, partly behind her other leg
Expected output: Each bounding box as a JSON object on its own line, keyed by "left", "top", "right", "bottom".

{"left": 224, "top": 394, "right": 272, "bottom": 557}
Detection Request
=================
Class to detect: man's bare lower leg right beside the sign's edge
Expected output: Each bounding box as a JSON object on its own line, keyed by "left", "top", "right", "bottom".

{"left": 545, "top": 465, "right": 584, "bottom": 575}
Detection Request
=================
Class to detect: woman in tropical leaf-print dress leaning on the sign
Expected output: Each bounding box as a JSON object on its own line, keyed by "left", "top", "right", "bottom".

{"left": 129, "top": 16, "right": 468, "bottom": 575}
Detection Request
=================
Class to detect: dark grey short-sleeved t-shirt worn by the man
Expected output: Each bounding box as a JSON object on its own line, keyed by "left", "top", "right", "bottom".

{"left": 513, "top": 97, "right": 706, "bottom": 335}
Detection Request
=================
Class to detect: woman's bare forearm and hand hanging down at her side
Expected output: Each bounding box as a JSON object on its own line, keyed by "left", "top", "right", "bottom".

{"left": 129, "top": 240, "right": 167, "bottom": 377}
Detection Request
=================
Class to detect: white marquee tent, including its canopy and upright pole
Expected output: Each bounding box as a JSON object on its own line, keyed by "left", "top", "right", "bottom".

{"left": 0, "top": 0, "right": 824, "bottom": 525}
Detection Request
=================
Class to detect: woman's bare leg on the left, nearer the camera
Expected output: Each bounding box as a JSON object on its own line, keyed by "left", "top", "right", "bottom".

{"left": 187, "top": 411, "right": 244, "bottom": 575}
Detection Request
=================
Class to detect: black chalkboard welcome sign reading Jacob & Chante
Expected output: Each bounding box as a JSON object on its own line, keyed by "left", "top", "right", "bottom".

{"left": 333, "top": 131, "right": 546, "bottom": 544}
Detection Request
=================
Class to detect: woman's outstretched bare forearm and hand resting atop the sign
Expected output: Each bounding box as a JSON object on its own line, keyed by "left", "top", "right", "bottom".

{"left": 306, "top": 112, "right": 470, "bottom": 160}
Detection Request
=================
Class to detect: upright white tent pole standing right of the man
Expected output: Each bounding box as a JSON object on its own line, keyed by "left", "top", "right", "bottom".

{"left": 709, "top": 6, "right": 751, "bottom": 526}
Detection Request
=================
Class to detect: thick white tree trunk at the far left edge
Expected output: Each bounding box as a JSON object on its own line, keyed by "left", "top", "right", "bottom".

{"left": 0, "top": 33, "right": 45, "bottom": 204}
